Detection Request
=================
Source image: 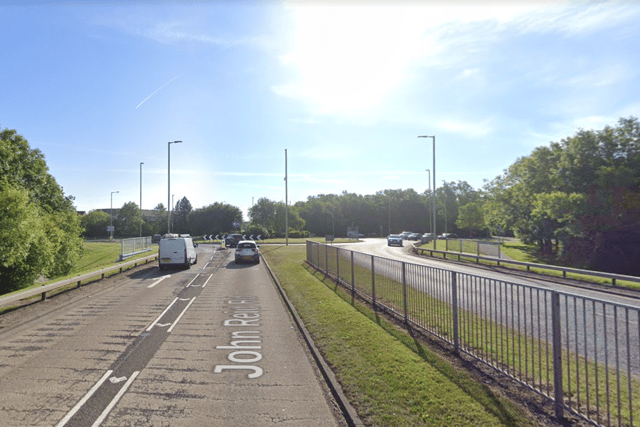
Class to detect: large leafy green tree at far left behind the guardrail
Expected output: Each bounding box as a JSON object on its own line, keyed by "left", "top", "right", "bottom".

{"left": 0, "top": 129, "right": 82, "bottom": 292}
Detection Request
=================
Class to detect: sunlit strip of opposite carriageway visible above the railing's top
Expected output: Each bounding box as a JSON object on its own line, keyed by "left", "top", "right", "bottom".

{"left": 340, "top": 239, "right": 640, "bottom": 307}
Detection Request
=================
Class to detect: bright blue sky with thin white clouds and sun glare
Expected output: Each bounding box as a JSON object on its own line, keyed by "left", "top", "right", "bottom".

{"left": 0, "top": 0, "right": 640, "bottom": 220}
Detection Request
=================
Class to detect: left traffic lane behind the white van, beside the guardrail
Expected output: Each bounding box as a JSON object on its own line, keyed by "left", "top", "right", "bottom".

{"left": 0, "top": 247, "right": 216, "bottom": 426}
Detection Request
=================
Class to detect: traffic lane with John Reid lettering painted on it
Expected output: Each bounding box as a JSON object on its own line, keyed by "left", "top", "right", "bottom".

{"left": 103, "top": 250, "right": 339, "bottom": 426}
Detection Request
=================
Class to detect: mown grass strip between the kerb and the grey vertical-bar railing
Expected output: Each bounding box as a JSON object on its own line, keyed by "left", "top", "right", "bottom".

{"left": 263, "top": 246, "right": 535, "bottom": 426}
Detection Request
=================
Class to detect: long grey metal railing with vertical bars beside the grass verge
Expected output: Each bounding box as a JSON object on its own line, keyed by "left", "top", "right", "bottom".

{"left": 307, "top": 241, "right": 640, "bottom": 426}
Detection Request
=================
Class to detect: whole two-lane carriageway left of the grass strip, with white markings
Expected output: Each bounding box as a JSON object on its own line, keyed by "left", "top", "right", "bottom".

{"left": 0, "top": 245, "right": 344, "bottom": 427}
